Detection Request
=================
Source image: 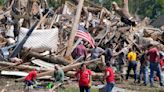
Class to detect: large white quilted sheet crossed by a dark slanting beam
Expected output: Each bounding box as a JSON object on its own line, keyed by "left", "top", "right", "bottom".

{"left": 7, "top": 28, "right": 58, "bottom": 51}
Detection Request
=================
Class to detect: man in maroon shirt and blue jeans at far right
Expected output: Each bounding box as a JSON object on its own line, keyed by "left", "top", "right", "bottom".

{"left": 147, "top": 45, "right": 163, "bottom": 87}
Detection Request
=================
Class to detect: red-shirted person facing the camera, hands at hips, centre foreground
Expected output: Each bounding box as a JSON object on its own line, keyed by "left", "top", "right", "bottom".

{"left": 75, "top": 64, "right": 92, "bottom": 92}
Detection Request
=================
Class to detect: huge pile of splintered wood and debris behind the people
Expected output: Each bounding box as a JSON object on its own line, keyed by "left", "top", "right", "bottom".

{"left": 0, "top": 0, "right": 164, "bottom": 90}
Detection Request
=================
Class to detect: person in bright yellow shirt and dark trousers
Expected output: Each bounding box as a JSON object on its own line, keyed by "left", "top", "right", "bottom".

{"left": 126, "top": 49, "right": 137, "bottom": 82}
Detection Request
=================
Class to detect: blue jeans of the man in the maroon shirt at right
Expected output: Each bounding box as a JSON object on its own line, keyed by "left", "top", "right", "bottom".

{"left": 150, "top": 62, "right": 163, "bottom": 86}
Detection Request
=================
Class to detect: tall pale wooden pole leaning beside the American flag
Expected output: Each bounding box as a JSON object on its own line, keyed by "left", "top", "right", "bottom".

{"left": 66, "top": 0, "right": 84, "bottom": 57}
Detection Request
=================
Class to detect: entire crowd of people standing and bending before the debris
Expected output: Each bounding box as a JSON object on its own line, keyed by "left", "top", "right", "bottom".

{"left": 25, "top": 42, "right": 164, "bottom": 92}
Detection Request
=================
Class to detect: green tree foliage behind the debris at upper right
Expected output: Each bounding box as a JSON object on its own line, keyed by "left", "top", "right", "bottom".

{"left": 92, "top": 0, "right": 164, "bottom": 19}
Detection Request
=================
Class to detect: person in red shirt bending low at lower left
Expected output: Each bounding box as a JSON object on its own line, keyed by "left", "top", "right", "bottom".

{"left": 24, "top": 69, "right": 37, "bottom": 86}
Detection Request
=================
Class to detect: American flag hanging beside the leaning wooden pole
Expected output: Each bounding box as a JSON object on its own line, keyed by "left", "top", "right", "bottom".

{"left": 76, "top": 25, "right": 95, "bottom": 47}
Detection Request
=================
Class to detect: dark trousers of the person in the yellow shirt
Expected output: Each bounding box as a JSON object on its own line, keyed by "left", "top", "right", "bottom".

{"left": 126, "top": 61, "right": 137, "bottom": 81}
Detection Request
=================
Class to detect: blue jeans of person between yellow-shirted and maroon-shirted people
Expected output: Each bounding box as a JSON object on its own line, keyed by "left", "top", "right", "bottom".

{"left": 139, "top": 66, "right": 148, "bottom": 85}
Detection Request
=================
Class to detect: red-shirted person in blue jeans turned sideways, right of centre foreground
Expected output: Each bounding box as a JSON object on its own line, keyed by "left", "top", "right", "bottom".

{"left": 104, "top": 63, "right": 115, "bottom": 92}
